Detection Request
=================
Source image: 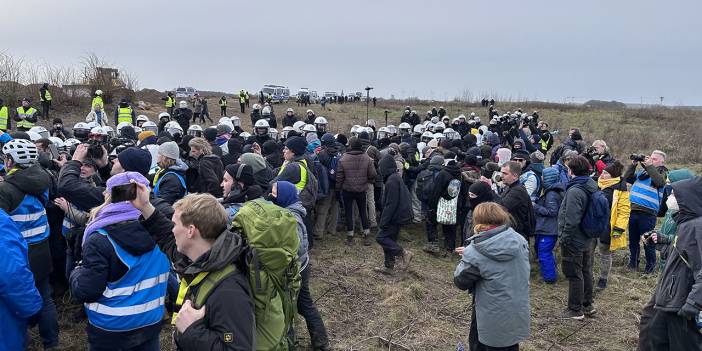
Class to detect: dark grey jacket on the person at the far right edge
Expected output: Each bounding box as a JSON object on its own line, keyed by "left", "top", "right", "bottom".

{"left": 654, "top": 177, "right": 702, "bottom": 313}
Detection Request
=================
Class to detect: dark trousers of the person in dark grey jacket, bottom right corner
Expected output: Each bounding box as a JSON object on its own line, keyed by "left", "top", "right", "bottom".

{"left": 648, "top": 310, "right": 702, "bottom": 351}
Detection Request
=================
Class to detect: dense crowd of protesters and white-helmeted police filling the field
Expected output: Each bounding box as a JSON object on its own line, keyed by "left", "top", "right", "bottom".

{"left": 0, "top": 94, "right": 702, "bottom": 350}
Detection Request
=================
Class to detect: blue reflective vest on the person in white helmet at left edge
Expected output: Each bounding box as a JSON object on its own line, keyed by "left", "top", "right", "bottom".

{"left": 10, "top": 190, "right": 49, "bottom": 245}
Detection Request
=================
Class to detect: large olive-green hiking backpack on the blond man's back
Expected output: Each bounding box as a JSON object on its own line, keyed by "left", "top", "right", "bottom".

{"left": 232, "top": 199, "right": 301, "bottom": 350}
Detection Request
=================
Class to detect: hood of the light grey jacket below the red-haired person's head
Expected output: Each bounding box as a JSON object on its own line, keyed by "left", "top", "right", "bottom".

{"left": 472, "top": 225, "right": 524, "bottom": 261}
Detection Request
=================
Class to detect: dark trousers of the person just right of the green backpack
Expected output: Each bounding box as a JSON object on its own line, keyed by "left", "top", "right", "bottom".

{"left": 288, "top": 264, "right": 329, "bottom": 350}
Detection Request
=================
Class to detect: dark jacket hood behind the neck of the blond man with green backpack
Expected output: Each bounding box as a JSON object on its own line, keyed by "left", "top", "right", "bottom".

{"left": 182, "top": 229, "right": 244, "bottom": 275}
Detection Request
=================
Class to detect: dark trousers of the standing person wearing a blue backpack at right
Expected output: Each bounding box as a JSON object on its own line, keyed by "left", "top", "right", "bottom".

{"left": 561, "top": 240, "right": 595, "bottom": 312}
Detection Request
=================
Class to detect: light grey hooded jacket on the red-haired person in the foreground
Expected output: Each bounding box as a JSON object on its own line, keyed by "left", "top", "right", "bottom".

{"left": 453, "top": 226, "right": 531, "bottom": 347}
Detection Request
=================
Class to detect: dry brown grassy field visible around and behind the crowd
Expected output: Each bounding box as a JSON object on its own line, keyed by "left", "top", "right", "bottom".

{"left": 24, "top": 97, "right": 702, "bottom": 351}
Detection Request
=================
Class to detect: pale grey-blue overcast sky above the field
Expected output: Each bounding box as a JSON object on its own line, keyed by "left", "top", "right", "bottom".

{"left": 5, "top": 0, "right": 702, "bottom": 105}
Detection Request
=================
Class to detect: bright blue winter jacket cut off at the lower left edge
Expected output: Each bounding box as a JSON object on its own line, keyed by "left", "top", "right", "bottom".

{"left": 0, "top": 210, "right": 42, "bottom": 351}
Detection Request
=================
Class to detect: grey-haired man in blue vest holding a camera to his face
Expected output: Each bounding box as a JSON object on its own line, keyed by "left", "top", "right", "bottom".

{"left": 623, "top": 150, "right": 668, "bottom": 274}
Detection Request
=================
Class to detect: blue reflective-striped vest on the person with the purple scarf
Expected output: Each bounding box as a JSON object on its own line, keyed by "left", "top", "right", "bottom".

{"left": 85, "top": 229, "right": 170, "bottom": 332}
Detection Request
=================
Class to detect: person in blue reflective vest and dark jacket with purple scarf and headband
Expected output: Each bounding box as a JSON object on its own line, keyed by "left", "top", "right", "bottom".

{"left": 70, "top": 172, "right": 170, "bottom": 350}
